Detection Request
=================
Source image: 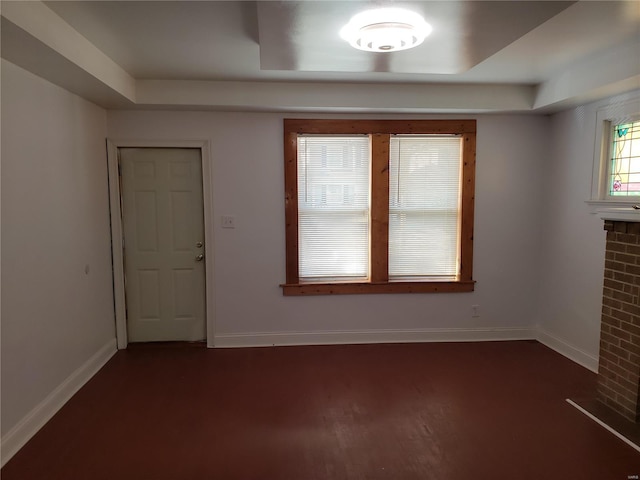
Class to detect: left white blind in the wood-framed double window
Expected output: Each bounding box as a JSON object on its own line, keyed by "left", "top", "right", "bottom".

{"left": 298, "top": 135, "right": 370, "bottom": 282}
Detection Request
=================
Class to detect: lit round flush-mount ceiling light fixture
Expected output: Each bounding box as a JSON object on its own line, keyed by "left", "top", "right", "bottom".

{"left": 340, "top": 8, "right": 432, "bottom": 52}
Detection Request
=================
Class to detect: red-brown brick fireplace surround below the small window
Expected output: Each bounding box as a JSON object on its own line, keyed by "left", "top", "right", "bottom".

{"left": 598, "top": 221, "right": 640, "bottom": 422}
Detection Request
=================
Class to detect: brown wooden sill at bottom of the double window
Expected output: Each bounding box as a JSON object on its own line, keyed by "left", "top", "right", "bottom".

{"left": 280, "top": 280, "right": 475, "bottom": 296}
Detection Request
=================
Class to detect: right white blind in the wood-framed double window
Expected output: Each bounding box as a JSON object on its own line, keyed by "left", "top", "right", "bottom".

{"left": 389, "top": 135, "right": 462, "bottom": 281}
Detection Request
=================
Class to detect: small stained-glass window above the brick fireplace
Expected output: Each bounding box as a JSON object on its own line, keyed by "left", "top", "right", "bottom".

{"left": 607, "top": 121, "right": 640, "bottom": 198}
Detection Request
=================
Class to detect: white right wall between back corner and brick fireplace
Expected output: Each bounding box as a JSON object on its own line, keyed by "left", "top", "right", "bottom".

{"left": 538, "top": 93, "right": 640, "bottom": 369}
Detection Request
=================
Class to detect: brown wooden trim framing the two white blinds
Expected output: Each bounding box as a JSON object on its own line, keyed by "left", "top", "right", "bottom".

{"left": 281, "top": 119, "right": 476, "bottom": 295}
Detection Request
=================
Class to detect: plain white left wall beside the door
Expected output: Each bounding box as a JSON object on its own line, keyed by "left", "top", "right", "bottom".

{"left": 2, "top": 60, "right": 115, "bottom": 440}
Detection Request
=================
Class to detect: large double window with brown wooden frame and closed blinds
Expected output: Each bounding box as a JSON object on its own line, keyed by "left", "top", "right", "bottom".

{"left": 282, "top": 120, "right": 476, "bottom": 295}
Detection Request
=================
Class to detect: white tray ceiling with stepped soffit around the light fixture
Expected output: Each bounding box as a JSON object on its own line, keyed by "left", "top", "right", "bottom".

{"left": 1, "top": 0, "right": 640, "bottom": 112}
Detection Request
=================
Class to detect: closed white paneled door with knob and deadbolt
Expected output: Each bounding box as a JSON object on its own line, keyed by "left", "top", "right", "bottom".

{"left": 119, "top": 148, "right": 206, "bottom": 342}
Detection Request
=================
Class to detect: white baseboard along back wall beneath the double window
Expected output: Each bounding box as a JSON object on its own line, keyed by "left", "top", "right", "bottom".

{"left": 215, "top": 327, "right": 536, "bottom": 348}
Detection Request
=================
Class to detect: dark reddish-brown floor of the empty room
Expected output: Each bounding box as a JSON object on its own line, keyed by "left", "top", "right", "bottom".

{"left": 0, "top": 341, "right": 640, "bottom": 480}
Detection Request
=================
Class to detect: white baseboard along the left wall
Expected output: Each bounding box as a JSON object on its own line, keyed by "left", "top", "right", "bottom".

{"left": 0, "top": 338, "right": 117, "bottom": 466}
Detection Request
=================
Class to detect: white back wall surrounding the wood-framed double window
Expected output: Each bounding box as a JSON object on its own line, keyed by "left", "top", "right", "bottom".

{"left": 108, "top": 111, "right": 549, "bottom": 345}
